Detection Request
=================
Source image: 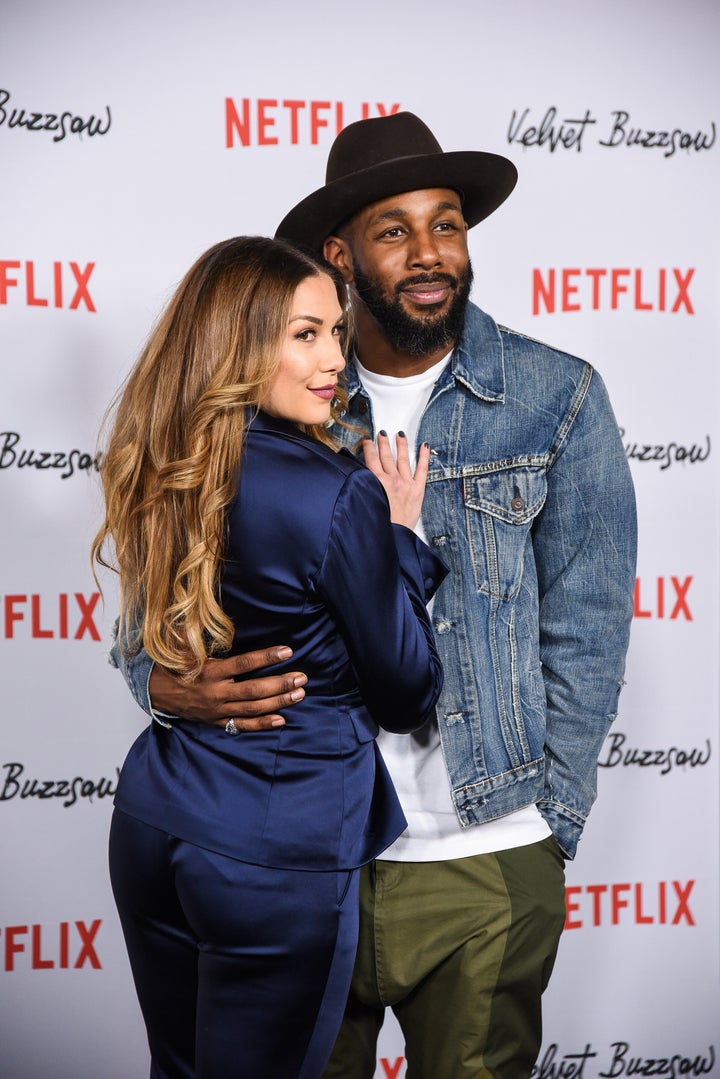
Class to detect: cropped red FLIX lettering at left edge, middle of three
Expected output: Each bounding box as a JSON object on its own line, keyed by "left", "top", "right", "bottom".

{"left": 0, "top": 592, "right": 100, "bottom": 641}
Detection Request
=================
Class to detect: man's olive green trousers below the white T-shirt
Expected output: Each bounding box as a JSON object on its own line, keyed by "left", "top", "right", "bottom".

{"left": 323, "top": 836, "right": 565, "bottom": 1079}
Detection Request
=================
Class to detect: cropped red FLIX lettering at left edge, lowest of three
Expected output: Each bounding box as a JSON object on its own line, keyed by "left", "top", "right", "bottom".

{"left": 0, "top": 918, "right": 103, "bottom": 972}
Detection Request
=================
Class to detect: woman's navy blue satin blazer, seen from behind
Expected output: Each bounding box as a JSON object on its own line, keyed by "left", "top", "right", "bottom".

{"left": 116, "top": 412, "right": 447, "bottom": 870}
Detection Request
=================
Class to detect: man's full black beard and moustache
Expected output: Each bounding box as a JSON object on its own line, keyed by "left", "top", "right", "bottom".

{"left": 353, "top": 260, "right": 473, "bottom": 356}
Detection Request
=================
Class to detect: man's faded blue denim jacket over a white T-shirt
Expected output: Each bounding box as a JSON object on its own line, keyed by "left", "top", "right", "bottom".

{"left": 116, "top": 304, "right": 636, "bottom": 858}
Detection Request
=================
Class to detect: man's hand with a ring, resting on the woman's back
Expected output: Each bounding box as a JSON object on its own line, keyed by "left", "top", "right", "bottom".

{"left": 149, "top": 646, "right": 308, "bottom": 730}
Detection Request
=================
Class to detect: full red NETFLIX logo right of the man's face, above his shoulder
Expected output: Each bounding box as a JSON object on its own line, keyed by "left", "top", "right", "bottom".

{"left": 532, "top": 267, "right": 695, "bottom": 315}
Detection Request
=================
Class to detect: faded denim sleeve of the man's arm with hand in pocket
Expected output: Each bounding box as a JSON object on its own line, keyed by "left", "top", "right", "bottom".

{"left": 533, "top": 368, "right": 637, "bottom": 857}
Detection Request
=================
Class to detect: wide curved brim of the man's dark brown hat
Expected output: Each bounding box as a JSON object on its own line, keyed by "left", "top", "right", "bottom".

{"left": 275, "top": 131, "right": 517, "bottom": 251}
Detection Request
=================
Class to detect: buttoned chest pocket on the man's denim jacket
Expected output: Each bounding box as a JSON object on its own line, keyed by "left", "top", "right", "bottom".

{"left": 463, "top": 464, "right": 547, "bottom": 600}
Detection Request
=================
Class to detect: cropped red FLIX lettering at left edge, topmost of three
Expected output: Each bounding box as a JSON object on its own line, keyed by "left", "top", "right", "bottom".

{"left": 0, "top": 259, "right": 95, "bottom": 312}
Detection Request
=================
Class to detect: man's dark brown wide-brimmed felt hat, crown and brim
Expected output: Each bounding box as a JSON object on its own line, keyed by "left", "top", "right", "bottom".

{"left": 275, "top": 112, "right": 517, "bottom": 250}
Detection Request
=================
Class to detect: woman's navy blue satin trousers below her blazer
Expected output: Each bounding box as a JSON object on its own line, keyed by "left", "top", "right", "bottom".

{"left": 110, "top": 809, "right": 359, "bottom": 1079}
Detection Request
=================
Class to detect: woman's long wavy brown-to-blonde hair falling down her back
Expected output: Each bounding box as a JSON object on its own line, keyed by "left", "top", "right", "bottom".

{"left": 92, "top": 236, "right": 347, "bottom": 680}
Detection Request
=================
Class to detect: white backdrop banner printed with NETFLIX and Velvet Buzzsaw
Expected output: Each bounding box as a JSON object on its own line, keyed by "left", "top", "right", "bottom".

{"left": 0, "top": 0, "right": 720, "bottom": 1079}
